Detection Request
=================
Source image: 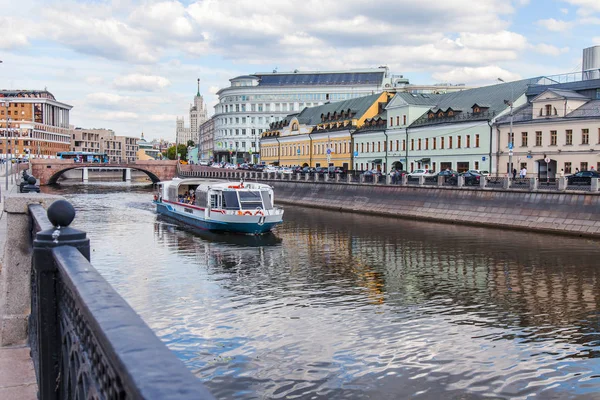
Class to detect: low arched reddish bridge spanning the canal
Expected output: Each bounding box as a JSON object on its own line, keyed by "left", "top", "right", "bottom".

{"left": 31, "top": 159, "right": 177, "bottom": 185}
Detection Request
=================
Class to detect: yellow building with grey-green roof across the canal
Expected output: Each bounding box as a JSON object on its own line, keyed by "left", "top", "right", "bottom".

{"left": 260, "top": 92, "right": 391, "bottom": 170}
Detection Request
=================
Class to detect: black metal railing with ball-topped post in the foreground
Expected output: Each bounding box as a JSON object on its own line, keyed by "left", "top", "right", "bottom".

{"left": 29, "top": 200, "right": 213, "bottom": 400}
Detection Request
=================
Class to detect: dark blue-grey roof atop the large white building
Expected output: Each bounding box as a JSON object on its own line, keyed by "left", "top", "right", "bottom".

{"left": 256, "top": 70, "right": 385, "bottom": 86}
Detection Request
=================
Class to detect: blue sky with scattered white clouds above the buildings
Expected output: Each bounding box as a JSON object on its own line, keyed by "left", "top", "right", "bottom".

{"left": 0, "top": 0, "right": 600, "bottom": 140}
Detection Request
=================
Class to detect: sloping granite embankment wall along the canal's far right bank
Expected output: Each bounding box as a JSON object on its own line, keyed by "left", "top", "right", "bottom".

{"left": 265, "top": 180, "right": 600, "bottom": 238}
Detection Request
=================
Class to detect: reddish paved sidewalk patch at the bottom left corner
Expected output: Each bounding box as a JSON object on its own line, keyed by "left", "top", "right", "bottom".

{"left": 0, "top": 346, "right": 37, "bottom": 400}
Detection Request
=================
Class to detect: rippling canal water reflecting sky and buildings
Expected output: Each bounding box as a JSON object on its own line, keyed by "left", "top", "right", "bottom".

{"left": 45, "top": 182, "right": 600, "bottom": 399}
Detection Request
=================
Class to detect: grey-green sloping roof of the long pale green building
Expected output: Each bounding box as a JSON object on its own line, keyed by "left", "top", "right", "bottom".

{"left": 411, "top": 77, "right": 540, "bottom": 126}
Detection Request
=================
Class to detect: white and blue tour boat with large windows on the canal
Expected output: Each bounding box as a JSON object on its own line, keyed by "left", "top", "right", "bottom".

{"left": 153, "top": 178, "right": 283, "bottom": 235}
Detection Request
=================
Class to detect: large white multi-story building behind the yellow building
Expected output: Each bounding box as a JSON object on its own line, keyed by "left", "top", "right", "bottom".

{"left": 213, "top": 67, "right": 408, "bottom": 162}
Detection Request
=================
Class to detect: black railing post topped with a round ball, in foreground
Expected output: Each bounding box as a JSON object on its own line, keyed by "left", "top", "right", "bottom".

{"left": 29, "top": 200, "right": 90, "bottom": 400}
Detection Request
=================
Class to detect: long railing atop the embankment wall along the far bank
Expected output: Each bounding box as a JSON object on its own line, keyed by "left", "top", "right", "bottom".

{"left": 179, "top": 167, "right": 600, "bottom": 193}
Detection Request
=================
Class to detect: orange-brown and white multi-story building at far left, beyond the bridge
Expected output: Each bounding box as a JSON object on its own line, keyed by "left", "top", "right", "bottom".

{"left": 0, "top": 90, "right": 72, "bottom": 158}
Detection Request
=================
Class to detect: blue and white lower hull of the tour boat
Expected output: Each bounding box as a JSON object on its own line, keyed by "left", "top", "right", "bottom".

{"left": 154, "top": 202, "right": 282, "bottom": 235}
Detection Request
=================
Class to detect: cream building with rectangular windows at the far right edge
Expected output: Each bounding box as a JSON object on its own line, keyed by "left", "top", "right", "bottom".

{"left": 495, "top": 85, "right": 600, "bottom": 179}
